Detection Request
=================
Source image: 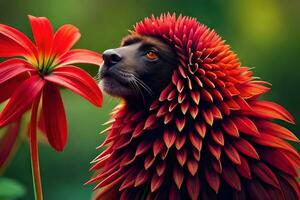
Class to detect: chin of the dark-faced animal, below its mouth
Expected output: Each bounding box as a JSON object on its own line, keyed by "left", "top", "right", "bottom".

{"left": 99, "top": 77, "right": 132, "bottom": 98}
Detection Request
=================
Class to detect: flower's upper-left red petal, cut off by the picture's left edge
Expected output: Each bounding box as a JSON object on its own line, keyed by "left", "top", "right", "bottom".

{"left": 0, "top": 24, "right": 36, "bottom": 57}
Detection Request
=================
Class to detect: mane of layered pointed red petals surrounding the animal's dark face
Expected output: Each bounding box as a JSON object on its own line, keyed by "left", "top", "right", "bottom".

{"left": 88, "top": 14, "right": 300, "bottom": 200}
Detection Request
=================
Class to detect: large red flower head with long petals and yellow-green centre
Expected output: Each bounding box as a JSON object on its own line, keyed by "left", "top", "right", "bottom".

{"left": 0, "top": 16, "right": 102, "bottom": 152}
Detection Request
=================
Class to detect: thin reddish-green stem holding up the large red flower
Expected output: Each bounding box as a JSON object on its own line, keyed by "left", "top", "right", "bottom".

{"left": 29, "top": 97, "right": 43, "bottom": 200}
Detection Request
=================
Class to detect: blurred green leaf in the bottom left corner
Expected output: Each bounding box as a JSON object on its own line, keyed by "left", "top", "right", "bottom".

{"left": 0, "top": 177, "right": 26, "bottom": 200}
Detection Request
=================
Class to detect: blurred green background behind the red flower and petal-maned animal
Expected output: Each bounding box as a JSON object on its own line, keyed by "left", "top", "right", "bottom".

{"left": 0, "top": 0, "right": 300, "bottom": 200}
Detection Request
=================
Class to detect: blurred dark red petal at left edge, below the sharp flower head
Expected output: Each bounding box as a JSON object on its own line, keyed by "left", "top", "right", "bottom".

{"left": 0, "top": 121, "right": 20, "bottom": 171}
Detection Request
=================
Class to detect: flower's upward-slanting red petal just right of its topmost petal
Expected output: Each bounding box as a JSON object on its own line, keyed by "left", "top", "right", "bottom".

{"left": 52, "top": 24, "right": 80, "bottom": 56}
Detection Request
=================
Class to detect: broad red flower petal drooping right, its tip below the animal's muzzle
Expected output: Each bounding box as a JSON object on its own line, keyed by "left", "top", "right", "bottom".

{"left": 45, "top": 66, "right": 103, "bottom": 106}
